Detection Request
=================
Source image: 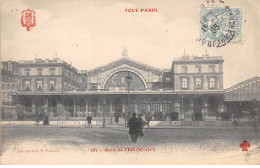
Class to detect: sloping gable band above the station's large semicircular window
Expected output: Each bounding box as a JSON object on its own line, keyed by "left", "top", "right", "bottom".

{"left": 88, "top": 57, "right": 163, "bottom": 76}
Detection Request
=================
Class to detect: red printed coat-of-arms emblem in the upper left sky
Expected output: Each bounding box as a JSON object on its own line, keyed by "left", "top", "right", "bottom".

{"left": 21, "top": 9, "right": 36, "bottom": 31}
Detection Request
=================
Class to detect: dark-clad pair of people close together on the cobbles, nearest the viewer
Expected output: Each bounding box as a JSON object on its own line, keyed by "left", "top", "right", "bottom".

{"left": 128, "top": 113, "right": 144, "bottom": 143}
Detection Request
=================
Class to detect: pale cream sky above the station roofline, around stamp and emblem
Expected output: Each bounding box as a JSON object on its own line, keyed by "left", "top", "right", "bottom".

{"left": 1, "top": 0, "right": 260, "bottom": 88}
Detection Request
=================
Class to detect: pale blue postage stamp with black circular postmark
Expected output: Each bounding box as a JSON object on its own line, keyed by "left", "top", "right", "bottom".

{"left": 200, "top": 6, "right": 243, "bottom": 47}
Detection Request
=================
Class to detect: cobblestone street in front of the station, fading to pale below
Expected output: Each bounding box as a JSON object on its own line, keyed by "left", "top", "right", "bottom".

{"left": 1, "top": 125, "right": 260, "bottom": 164}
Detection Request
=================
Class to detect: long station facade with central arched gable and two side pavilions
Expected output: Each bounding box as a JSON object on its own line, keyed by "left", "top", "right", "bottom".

{"left": 3, "top": 50, "right": 224, "bottom": 120}
